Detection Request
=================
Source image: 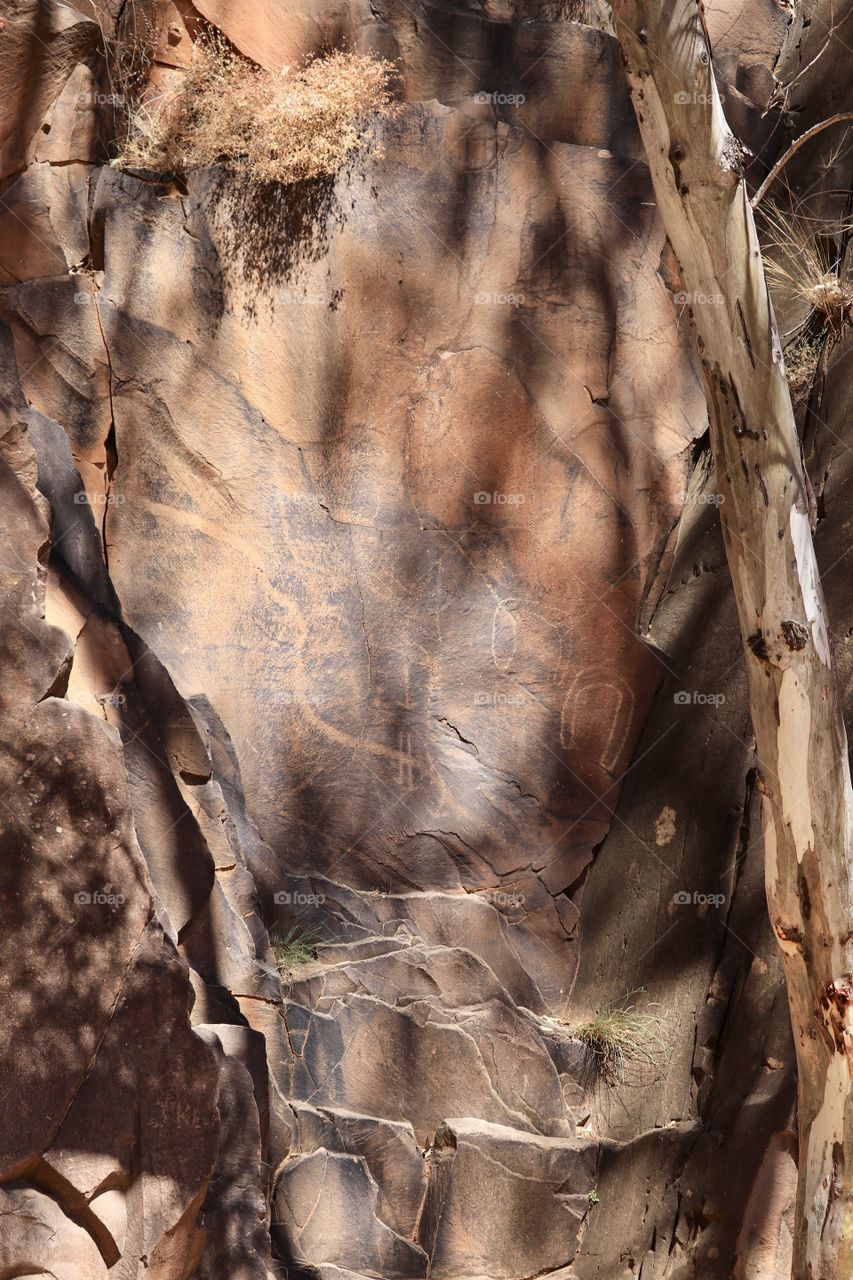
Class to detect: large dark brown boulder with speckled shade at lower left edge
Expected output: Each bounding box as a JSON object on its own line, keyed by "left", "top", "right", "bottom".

{"left": 0, "top": 320, "right": 218, "bottom": 1277}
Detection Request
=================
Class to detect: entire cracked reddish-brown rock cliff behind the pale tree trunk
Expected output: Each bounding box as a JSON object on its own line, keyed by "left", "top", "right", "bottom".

{"left": 0, "top": 0, "right": 853, "bottom": 1280}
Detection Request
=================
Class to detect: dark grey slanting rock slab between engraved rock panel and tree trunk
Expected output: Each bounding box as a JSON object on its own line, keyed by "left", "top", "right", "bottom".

{"left": 563, "top": 460, "right": 795, "bottom": 1280}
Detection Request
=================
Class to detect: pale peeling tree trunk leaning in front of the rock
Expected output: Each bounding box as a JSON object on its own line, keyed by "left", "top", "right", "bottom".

{"left": 613, "top": 0, "right": 853, "bottom": 1280}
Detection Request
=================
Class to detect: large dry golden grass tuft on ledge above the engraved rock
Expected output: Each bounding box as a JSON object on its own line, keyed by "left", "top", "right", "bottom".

{"left": 115, "top": 31, "right": 394, "bottom": 183}
